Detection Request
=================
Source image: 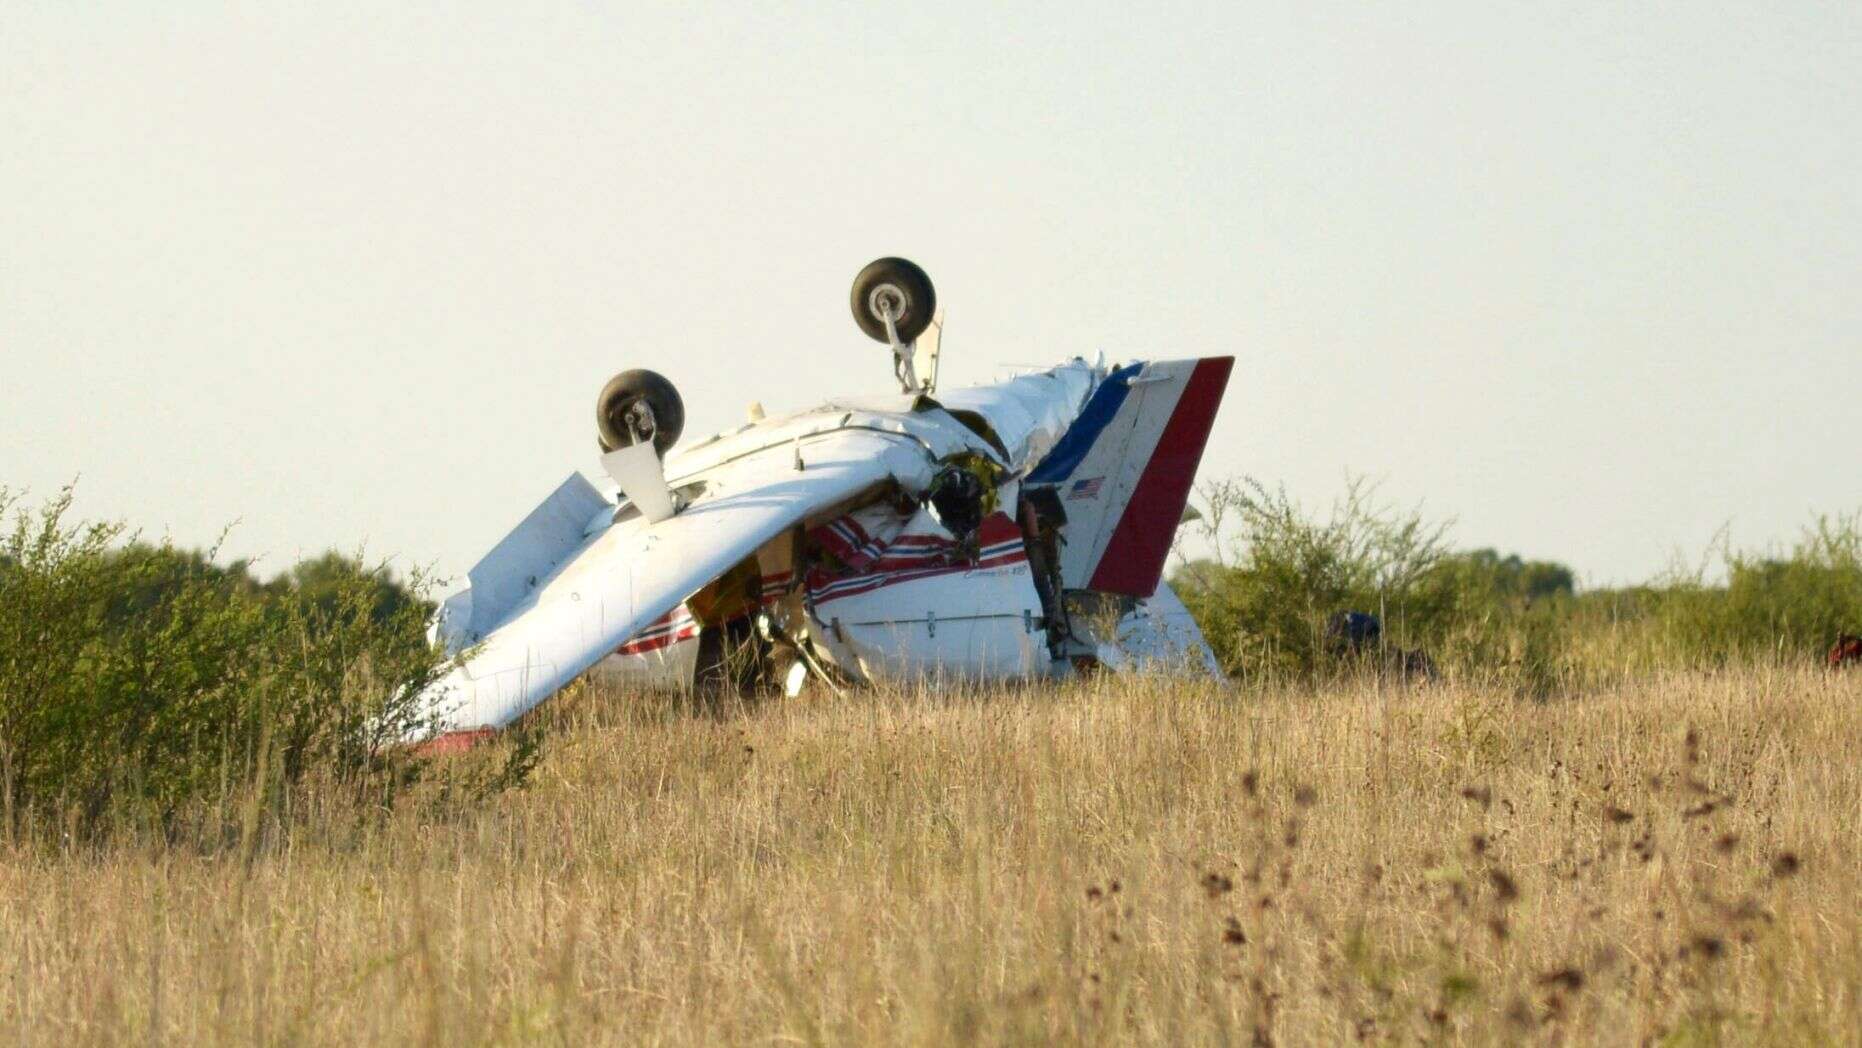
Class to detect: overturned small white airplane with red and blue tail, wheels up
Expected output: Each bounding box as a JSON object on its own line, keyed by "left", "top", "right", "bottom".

{"left": 421, "top": 259, "right": 1235, "bottom": 735}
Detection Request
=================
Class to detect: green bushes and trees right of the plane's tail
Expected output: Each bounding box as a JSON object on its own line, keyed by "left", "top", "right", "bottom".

{"left": 1171, "top": 478, "right": 1862, "bottom": 694}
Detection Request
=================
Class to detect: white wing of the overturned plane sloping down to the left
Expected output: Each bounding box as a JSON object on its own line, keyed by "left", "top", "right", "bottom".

{"left": 420, "top": 430, "right": 937, "bottom": 741}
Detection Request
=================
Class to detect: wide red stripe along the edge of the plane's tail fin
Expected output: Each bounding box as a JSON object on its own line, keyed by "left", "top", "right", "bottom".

{"left": 1087, "top": 357, "right": 1235, "bottom": 598}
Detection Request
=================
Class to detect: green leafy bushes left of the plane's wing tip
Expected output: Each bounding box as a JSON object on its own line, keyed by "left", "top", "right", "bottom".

{"left": 0, "top": 490, "right": 532, "bottom": 843}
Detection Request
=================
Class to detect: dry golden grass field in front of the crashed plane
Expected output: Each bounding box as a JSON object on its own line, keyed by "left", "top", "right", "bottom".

{"left": 0, "top": 670, "right": 1862, "bottom": 1046}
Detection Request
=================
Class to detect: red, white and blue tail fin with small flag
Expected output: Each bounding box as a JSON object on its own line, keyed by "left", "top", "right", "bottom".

{"left": 1026, "top": 357, "right": 1235, "bottom": 599}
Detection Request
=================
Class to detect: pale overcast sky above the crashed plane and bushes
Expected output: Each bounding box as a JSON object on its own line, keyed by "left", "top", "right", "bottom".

{"left": 0, "top": 0, "right": 1862, "bottom": 583}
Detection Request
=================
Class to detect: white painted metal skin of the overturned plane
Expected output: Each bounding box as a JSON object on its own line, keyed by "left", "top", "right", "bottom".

{"left": 421, "top": 361, "right": 1236, "bottom": 732}
